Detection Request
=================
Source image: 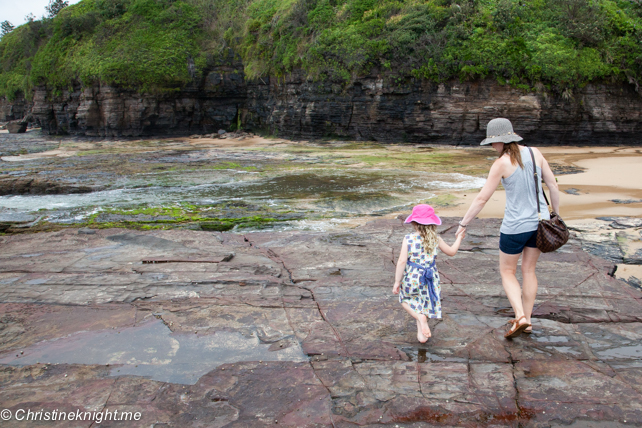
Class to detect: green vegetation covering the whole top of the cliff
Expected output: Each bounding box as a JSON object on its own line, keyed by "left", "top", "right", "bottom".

{"left": 0, "top": 0, "right": 642, "bottom": 98}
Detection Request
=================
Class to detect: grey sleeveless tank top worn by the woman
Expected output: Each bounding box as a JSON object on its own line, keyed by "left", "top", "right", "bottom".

{"left": 499, "top": 147, "right": 551, "bottom": 235}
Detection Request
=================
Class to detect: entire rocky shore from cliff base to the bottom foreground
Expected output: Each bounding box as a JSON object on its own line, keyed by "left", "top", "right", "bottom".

{"left": 0, "top": 130, "right": 642, "bottom": 428}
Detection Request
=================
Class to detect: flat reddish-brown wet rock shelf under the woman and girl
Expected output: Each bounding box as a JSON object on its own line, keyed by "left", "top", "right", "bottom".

{"left": 0, "top": 218, "right": 642, "bottom": 427}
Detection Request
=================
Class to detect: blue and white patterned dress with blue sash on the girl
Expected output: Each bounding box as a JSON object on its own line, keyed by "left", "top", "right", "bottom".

{"left": 399, "top": 232, "right": 441, "bottom": 318}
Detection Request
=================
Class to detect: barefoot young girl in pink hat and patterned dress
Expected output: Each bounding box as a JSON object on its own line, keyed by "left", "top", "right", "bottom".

{"left": 392, "top": 204, "right": 465, "bottom": 343}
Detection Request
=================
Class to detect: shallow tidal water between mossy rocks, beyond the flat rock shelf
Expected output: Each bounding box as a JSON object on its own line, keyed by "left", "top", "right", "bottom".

{"left": 0, "top": 169, "right": 485, "bottom": 229}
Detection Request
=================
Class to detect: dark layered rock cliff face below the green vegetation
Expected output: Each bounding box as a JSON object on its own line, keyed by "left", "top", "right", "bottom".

{"left": 3, "top": 70, "right": 642, "bottom": 145}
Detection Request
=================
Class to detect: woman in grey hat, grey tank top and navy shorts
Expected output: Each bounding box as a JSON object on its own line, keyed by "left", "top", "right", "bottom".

{"left": 457, "top": 118, "right": 559, "bottom": 338}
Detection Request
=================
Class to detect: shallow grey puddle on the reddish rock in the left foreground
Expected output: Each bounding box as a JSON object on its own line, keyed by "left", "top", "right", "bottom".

{"left": 0, "top": 320, "right": 308, "bottom": 385}
